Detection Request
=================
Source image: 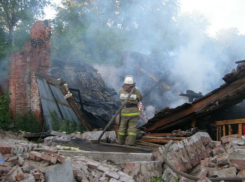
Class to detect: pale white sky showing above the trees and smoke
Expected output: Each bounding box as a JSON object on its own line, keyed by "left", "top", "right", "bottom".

{"left": 45, "top": 0, "right": 245, "bottom": 37}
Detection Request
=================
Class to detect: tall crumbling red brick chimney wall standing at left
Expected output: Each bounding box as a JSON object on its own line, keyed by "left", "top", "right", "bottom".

{"left": 9, "top": 20, "right": 51, "bottom": 121}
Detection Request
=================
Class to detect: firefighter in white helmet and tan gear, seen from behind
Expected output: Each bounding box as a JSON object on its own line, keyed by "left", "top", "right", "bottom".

{"left": 118, "top": 75, "right": 143, "bottom": 145}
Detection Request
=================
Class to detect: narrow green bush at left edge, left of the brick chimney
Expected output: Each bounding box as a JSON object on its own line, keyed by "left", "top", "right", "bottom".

{"left": 0, "top": 92, "right": 11, "bottom": 129}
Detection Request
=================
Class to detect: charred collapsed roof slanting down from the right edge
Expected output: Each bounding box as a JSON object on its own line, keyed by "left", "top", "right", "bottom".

{"left": 142, "top": 63, "right": 245, "bottom": 132}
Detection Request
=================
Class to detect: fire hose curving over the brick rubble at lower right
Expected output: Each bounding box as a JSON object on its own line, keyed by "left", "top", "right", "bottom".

{"left": 164, "top": 140, "right": 245, "bottom": 181}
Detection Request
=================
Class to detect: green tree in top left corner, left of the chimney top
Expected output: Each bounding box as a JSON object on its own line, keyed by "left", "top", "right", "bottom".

{"left": 0, "top": 0, "right": 50, "bottom": 44}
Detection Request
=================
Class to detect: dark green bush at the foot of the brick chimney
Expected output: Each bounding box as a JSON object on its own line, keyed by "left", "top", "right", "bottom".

{"left": 15, "top": 110, "right": 42, "bottom": 133}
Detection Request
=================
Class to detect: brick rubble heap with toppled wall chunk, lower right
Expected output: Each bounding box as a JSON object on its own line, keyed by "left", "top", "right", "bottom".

{"left": 153, "top": 132, "right": 245, "bottom": 181}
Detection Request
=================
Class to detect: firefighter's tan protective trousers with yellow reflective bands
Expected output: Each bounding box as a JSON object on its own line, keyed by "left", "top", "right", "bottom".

{"left": 118, "top": 116, "right": 138, "bottom": 145}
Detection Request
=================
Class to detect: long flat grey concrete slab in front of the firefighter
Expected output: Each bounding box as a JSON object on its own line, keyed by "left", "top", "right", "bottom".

{"left": 58, "top": 150, "right": 153, "bottom": 165}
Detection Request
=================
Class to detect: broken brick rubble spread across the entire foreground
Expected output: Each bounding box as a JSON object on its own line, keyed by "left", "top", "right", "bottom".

{"left": 0, "top": 131, "right": 245, "bottom": 182}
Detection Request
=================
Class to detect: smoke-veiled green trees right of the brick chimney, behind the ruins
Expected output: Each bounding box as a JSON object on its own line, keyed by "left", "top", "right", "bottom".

{"left": 52, "top": 0, "right": 179, "bottom": 64}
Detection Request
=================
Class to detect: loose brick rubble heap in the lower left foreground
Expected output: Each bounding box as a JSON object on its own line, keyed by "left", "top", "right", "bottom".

{"left": 0, "top": 132, "right": 135, "bottom": 182}
